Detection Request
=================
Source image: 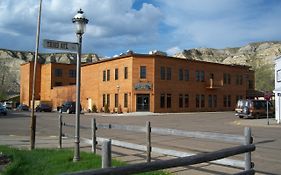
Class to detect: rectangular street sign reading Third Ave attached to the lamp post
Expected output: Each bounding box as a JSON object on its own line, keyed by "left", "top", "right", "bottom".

{"left": 43, "top": 39, "right": 78, "bottom": 51}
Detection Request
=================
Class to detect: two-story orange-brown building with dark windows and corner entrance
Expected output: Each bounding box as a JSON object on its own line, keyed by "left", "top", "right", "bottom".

{"left": 21, "top": 53, "right": 255, "bottom": 112}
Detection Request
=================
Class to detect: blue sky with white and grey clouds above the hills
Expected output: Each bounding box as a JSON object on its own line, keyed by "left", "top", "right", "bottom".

{"left": 0, "top": 0, "right": 281, "bottom": 57}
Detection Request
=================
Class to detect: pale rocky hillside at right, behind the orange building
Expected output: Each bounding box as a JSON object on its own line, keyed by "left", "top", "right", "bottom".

{"left": 174, "top": 41, "right": 281, "bottom": 91}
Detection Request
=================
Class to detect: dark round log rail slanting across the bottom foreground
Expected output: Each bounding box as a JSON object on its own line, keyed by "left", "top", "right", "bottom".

{"left": 63, "top": 144, "right": 255, "bottom": 175}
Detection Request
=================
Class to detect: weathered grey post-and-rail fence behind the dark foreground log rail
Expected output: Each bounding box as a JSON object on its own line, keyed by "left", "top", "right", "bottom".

{"left": 59, "top": 115, "right": 255, "bottom": 172}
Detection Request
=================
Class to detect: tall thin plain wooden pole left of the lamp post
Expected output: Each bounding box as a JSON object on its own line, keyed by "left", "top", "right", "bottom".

{"left": 30, "top": 0, "right": 42, "bottom": 150}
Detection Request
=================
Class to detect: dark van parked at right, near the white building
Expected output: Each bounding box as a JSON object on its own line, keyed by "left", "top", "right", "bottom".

{"left": 235, "top": 99, "right": 274, "bottom": 118}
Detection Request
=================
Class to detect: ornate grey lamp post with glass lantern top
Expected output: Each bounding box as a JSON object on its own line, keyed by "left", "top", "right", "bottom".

{"left": 72, "top": 9, "right": 88, "bottom": 162}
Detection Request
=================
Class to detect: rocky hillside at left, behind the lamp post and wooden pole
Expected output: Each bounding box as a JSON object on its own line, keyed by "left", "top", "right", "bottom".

{"left": 0, "top": 49, "right": 99, "bottom": 100}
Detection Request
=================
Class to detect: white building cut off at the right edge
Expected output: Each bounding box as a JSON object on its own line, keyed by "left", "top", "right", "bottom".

{"left": 274, "top": 56, "right": 281, "bottom": 124}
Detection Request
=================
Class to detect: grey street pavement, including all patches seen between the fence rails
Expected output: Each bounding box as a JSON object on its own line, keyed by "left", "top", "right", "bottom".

{"left": 0, "top": 112, "right": 281, "bottom": 175}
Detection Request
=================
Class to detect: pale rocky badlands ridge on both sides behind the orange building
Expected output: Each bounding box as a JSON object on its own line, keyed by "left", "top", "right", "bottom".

{"left": 0, "top": 41, "right": 281, "bottom": 98}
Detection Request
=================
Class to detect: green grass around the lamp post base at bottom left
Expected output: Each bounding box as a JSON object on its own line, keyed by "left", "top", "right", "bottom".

{"left": 0, "top": 146, "right": 167, "bottom": 175}
